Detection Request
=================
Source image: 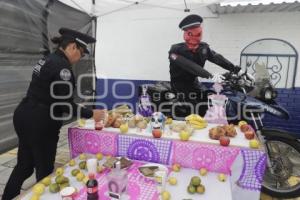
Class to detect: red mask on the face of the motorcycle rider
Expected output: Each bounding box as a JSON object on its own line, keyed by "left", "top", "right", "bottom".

{"left": 183, "top": 26, "right": 202, "bottom": 51}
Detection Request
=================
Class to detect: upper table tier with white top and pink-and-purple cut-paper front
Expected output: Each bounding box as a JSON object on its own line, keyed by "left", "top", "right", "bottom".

{"left": 68, "top": 124, "right": 266, "bottom": 200}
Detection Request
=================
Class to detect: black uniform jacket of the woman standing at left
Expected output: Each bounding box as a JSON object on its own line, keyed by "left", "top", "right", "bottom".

{"left": 27, "top": 50, "right": 93, "bottom": 118}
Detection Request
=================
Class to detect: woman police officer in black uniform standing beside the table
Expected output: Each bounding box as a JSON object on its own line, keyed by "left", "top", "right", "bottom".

{"left": 2, "top": 28, "right": 105, "bottom": 200}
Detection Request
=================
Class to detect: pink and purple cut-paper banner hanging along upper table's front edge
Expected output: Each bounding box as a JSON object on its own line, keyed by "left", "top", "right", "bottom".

{"left": 69, "top": 128, "right": 266, "bottom": 191}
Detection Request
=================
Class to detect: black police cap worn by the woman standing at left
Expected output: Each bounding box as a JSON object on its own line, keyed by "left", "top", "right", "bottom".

{"left": 58, "top": 28, "right": 96, "bottom": 53}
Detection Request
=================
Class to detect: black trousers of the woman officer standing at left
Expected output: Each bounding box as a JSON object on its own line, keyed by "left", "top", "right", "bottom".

{"left": 2, "top": 98, "right": 61, "bottom": 200}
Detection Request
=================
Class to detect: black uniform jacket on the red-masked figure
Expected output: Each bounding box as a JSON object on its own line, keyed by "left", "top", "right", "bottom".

{"left": 169, "top": 42, "right": 240, "bottom": 93}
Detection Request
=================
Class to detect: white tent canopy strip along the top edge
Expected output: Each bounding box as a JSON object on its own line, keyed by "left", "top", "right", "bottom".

{"left": 60, "top": 0, "right": 299, "bottom": 16}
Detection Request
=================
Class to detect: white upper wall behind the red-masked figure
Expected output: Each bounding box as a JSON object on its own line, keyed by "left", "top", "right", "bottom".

{"left": 96, "top": 7, "right": 300, "bottom": 86}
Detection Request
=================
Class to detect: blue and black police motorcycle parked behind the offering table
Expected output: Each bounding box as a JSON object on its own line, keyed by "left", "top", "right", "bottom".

{"left": 141, "top": 63, "right": 300, "bottom": 198}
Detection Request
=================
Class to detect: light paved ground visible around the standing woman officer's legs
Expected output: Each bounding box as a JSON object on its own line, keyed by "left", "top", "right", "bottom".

{"left": 0, "top": 124, "right": 300, "bottom": 200}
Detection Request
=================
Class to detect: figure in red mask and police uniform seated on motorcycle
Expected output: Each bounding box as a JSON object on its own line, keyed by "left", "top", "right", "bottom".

{"left": 169, "top": 15, "right": 240, "bottom": 117}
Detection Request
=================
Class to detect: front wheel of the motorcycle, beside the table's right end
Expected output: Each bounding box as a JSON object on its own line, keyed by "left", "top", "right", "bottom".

{"left": 262, "top": 138, "right": 300, "bottom": 198}
